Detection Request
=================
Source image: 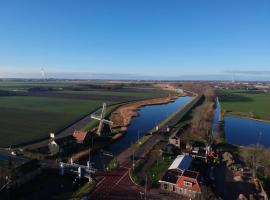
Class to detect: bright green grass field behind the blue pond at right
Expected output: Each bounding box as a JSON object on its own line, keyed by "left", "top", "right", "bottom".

{"left": 218, "top": 90, "right": 270, "bottom": 120}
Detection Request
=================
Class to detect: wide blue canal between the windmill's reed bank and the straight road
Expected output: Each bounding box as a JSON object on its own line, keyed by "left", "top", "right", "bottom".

{"left": 84, "top": 96, "right": 192, "bottom": 169}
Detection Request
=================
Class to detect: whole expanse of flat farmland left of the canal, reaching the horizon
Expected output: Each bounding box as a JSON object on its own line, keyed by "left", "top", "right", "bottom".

{"left": 0, "top": 81, "right": 171, "bottom": 147}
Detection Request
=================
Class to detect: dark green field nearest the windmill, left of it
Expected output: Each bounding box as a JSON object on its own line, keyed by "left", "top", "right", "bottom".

{"left": 0, "top": 96, "right": 105, "bottom": 146}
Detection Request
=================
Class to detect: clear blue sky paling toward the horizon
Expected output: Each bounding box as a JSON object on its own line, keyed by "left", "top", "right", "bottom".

{"left": 0, "top": 0, "right": 270, "bottom": 80}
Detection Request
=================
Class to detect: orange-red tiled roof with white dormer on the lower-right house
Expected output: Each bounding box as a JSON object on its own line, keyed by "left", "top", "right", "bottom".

{"left": 176, "top": 170, "right": 201, "bottom": 192}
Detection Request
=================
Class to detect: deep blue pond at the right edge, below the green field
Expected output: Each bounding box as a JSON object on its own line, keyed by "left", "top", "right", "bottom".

{"left": 224, "top": 117, "right": 270, "bottom": 147}
